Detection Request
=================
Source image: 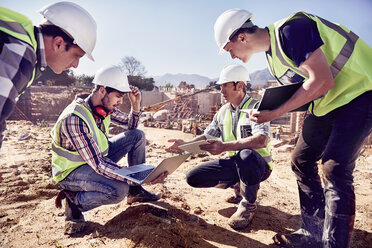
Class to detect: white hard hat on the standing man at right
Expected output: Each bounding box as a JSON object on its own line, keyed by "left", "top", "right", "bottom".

{"left": 214, "top": 9, "right": 253, "bottom": 54}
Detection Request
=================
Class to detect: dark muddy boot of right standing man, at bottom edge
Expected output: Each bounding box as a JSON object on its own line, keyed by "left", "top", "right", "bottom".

{"left": 273, "top": 228, "right": 322, "bottom": 248}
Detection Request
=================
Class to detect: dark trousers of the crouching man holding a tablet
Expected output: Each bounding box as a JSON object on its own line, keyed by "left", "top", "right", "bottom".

{"left": 186, "top": 149, "right": 271, "bottom": 201}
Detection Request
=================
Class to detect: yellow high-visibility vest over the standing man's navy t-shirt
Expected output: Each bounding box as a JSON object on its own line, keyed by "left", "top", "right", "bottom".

{"left": 266, "top": 12, "right": 372, "bottom": 116}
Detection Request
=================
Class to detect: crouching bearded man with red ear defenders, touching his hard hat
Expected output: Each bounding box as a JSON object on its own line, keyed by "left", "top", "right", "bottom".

{"left": 51, "top": 66, "right": 165, "bottom": 233}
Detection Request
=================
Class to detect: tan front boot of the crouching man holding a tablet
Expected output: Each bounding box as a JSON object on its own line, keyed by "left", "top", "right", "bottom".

{"left": 227, "top": 198, "right": 257, "bottom": 230}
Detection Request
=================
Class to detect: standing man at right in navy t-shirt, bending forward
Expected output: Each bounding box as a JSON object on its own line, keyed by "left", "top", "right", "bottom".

{"left": 214, "top": 9, "right": 372, "bottom": 248}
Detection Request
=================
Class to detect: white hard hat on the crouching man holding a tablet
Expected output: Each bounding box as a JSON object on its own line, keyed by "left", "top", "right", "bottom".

{"left": 217, "top": 65, "right": 250, "bottom": 85}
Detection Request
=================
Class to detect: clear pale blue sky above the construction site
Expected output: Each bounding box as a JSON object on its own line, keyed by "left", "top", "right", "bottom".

{"left": 0, "top": 0, "right": 372, "bottom": 78}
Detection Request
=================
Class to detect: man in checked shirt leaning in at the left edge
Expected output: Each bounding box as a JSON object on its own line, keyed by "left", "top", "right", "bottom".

{"left": 0, "top": 2, "right": 96, "bottom": 155}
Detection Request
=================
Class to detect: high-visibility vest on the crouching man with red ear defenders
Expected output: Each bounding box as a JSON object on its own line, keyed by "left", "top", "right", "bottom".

{"left": 51, "top": 101, "right": 110, "bottom": 182}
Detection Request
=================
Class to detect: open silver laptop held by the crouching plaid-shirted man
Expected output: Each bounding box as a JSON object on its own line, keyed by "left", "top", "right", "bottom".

{"left": 113, "top": 153, "right": 191, "bottom": 184}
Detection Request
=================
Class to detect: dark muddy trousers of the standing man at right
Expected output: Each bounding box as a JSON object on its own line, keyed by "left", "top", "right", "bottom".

{"left": 292, "top": 91, "right": 372, "bottom": 248}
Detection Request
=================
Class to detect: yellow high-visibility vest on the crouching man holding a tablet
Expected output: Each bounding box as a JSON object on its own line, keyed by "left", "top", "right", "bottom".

{"left": 217, "top": 98, "right": 273, "bottom": 169}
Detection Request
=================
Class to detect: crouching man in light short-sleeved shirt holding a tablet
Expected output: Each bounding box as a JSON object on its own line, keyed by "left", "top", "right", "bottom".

{"left": 167, "top": 65, "right": 272, "bottom": 229}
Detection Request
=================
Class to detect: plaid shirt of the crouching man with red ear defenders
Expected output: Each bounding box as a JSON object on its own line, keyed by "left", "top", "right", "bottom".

{"left": 56, "top": 99, "right": 141, "bottom": 182}
